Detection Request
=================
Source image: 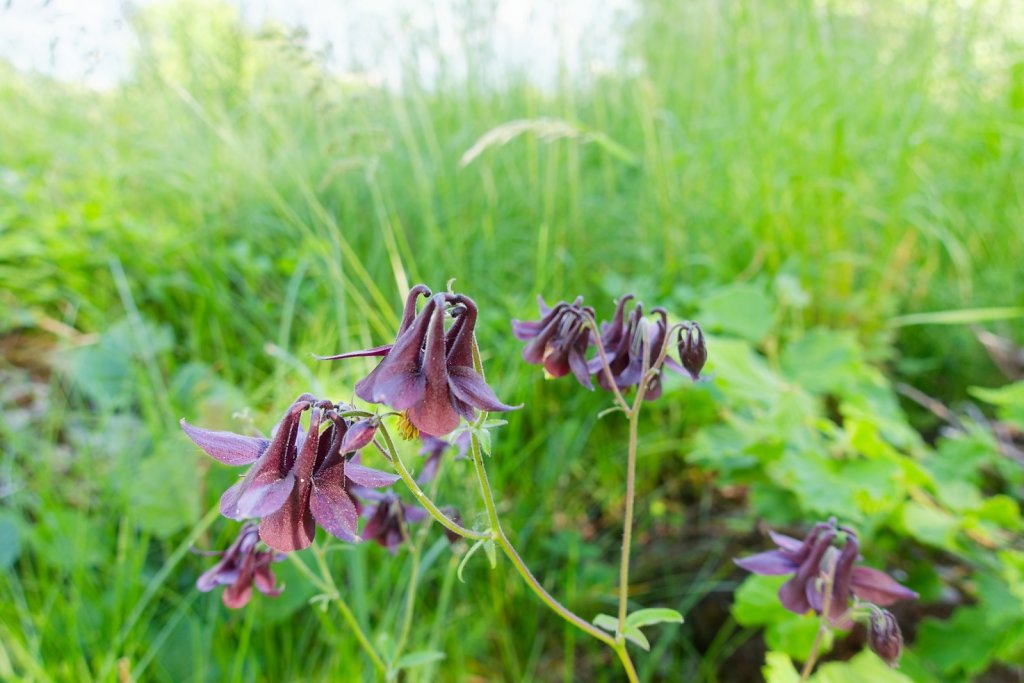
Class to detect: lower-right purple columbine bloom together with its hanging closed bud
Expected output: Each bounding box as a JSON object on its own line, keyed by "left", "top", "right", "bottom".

{"left": 735, "top": 518, "right": 918, "bottom": 665}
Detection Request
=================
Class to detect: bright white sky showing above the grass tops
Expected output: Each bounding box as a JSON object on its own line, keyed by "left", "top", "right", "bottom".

{"left": 0, "top": 0, "right": 632, "bottom": 88}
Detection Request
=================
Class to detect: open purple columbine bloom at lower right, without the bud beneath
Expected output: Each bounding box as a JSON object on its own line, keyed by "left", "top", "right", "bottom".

{"left": 733, "top": 519, "right": 918, "bottom": 628}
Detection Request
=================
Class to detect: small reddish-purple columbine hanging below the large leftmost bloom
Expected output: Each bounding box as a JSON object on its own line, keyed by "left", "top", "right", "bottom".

{"left": 196, "top": 522, "right": 285, "bottom": 609}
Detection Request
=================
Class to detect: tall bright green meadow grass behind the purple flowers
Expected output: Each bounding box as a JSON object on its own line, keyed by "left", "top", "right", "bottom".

{"left": 0, "top": 0, "right": 1024, "bottom": 681}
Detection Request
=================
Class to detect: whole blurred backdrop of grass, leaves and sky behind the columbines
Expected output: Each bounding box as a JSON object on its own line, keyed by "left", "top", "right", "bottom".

{"left": 0, "top": 0, "right": 1024, "bottom": 683}
